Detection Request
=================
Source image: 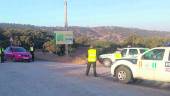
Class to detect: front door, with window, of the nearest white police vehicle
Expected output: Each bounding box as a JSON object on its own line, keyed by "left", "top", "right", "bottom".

{"left": 140, "top": 49, "right": 165, "bottom": 80}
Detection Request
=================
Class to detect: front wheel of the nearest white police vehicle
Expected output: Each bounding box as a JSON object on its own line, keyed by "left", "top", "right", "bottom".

{"left": 116, "top": 66, "right": 133, "bottom": 83}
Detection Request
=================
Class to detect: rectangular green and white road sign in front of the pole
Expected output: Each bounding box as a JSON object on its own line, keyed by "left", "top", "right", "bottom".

{"left": 54, "top": 31, "right": 73, "bottom": 44}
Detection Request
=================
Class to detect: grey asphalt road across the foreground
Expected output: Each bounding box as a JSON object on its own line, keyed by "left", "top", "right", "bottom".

{"left": 0, "top": 61, "right": 170, "bottom": 96}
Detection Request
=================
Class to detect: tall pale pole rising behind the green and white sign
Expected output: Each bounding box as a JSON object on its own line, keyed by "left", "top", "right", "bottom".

{"left": 64, "top": 0, "right": 69, "bottom": 56}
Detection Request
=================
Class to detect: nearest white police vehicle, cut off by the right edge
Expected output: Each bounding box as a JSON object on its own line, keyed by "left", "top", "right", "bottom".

{"left": 111, "top": 47, "right": 170, "bottom": 83}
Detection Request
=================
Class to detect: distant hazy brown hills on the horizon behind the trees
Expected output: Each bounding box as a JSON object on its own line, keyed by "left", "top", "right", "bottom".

{"left": 0, "top": 23, "right": 170, "bottom": 41}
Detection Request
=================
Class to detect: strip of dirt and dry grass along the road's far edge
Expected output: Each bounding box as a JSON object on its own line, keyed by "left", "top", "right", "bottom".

{"left": 35, "top": 47, "right": 101, "bottom": 65}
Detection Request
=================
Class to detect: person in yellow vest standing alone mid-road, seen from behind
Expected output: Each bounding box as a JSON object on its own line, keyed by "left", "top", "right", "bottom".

{"left": 86, "top": 46, "right": 97, "bottom": 77}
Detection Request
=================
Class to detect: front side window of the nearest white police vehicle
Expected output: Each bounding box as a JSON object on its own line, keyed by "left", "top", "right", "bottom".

{"left": 142, "top": 49, "right": 165, "bottom": 60}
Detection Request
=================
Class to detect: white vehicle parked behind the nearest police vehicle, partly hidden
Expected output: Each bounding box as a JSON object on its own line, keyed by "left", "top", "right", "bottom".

{"left": 99, "top": 47, "right": 148, "bottom": 67}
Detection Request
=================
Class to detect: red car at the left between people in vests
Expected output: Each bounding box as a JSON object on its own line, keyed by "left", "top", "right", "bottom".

{"left": 4, "top": 46, "right": 32, "bottom": 61}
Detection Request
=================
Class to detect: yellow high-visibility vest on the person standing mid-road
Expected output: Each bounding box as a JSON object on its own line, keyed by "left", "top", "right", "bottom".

{"left": 88, "top": 49, "right": 97, "bottom": 62}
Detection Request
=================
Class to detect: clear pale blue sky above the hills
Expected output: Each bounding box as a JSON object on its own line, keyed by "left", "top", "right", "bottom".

{"left": 0, "top": 0, "right": 170, "bottom": 31}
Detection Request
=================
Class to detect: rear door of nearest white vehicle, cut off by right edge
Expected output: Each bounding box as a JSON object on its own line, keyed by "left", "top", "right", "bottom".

{"left": 155, "top": 50, "right": 170, "bottom": 82}
